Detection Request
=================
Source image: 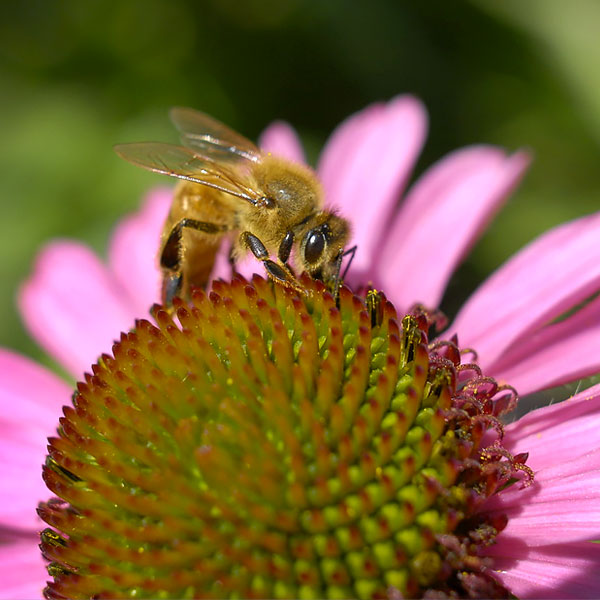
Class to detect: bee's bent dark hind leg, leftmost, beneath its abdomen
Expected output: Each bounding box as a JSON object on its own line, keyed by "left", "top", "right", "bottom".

{"left": 160, "top": 218, "right": 228, "bottom": 306}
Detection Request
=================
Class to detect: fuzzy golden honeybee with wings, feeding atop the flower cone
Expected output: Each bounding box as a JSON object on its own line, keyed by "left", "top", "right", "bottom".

{"left": 115, "top": 108, "right": 355, "bottom": 306}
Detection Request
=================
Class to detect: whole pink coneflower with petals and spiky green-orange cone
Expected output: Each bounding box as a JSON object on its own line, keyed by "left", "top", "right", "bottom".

{"left": 0, "top": 97, "right": 600, "bottom": 598}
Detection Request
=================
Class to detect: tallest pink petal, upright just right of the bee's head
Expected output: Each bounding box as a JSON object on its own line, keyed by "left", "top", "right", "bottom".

{"left": 319, "top": 96, "right": 427, "bottom": 283}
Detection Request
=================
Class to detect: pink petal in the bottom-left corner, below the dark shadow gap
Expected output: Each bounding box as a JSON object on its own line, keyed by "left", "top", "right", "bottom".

{"left": 0, "top": 532, "right": 49, "bottom": 600}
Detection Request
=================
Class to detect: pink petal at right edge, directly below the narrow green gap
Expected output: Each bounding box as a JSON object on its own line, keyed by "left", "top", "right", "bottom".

{"left": 504, "top": 386, "right": 600, "bottom": 471}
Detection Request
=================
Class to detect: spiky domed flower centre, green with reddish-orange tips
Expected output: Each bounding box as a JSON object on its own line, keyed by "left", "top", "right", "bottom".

{"left": 38, "top": 277, "right": 530, "bottom": 599}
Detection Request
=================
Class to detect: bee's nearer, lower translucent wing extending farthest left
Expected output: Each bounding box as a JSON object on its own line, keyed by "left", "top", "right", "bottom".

{"left": 114, "top": 142, "right": 261, "bottom": 204}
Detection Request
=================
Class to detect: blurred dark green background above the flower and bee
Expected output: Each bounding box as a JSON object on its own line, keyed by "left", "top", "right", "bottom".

{"left": 0, "top": 0, "right": 600, "bottom": 370}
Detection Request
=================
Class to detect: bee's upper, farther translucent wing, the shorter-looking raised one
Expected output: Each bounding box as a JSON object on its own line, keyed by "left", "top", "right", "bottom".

{"left": 169, "top": 107, "right": 260, "bottom": 161}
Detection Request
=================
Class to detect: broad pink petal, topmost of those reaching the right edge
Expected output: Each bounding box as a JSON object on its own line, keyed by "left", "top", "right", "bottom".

{"left": 449, "top": 213, "right": 600, "bottom": 370}
